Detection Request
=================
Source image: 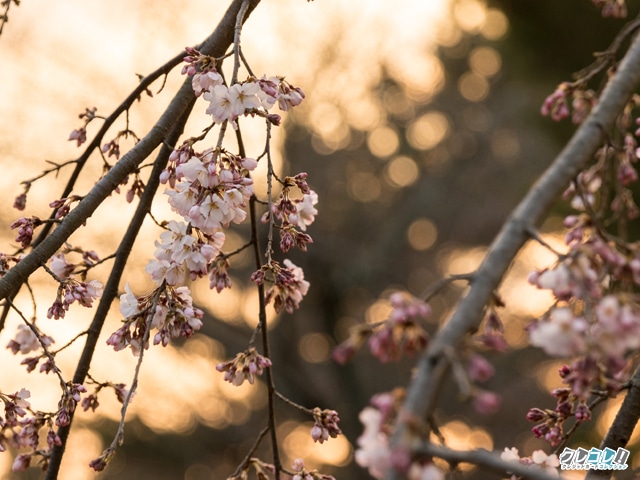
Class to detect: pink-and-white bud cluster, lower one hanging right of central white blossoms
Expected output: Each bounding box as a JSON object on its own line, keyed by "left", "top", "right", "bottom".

{"left": 251, "top": 260, "right": 309, "bottom": 313}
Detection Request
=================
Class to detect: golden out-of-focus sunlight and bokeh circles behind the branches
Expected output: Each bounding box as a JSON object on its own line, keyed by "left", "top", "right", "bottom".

{"left": 0, "top": 0, "right": 635, "bottom": 480}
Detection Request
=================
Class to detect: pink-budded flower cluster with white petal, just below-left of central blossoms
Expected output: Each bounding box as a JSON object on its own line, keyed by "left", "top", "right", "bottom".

{"left": 107, "top": 285, "right": 204, "bottom": 356}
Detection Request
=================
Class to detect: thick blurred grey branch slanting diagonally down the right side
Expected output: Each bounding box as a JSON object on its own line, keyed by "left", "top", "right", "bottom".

{"left": 386, "top": 21, "right": 640, "bottom": 479}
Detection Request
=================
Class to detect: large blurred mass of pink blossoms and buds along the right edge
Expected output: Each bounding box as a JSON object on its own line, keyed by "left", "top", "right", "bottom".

{"left": 527, "top": 80, "right": 640, "bottom": 446}
